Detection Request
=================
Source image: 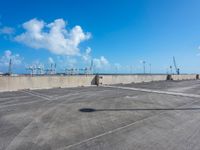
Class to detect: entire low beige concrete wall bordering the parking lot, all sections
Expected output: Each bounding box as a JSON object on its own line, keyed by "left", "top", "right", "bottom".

{"left": 0, "top": 74, "right": 197, "bottom": 92}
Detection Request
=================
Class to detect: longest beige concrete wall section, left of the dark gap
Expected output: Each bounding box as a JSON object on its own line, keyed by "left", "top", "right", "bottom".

{"left": 0, "top": 75, "right": 95, "bottom": 92}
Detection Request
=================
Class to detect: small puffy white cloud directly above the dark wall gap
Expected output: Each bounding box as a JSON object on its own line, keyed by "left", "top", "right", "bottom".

{"left": 93, "top": 56, "right": 109, "bottom": 69}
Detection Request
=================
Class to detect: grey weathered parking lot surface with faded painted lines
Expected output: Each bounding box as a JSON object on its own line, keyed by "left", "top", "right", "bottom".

{"left": 0, "top": 80, "right": 200, "bottom": 150}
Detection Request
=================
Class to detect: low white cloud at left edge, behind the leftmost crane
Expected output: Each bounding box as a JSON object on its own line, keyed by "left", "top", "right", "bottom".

{"left": 0, "top": 50, "right": 23, "bottom": 66}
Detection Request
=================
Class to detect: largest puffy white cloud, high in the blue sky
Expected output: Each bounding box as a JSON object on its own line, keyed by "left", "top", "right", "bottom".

{"left": 15, "top": 19, "right": 91, "bottom": 56}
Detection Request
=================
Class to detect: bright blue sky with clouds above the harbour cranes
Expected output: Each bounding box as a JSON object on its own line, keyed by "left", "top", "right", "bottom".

{"left": 0, "top": 0, "right": 200, "bottom": 73}
